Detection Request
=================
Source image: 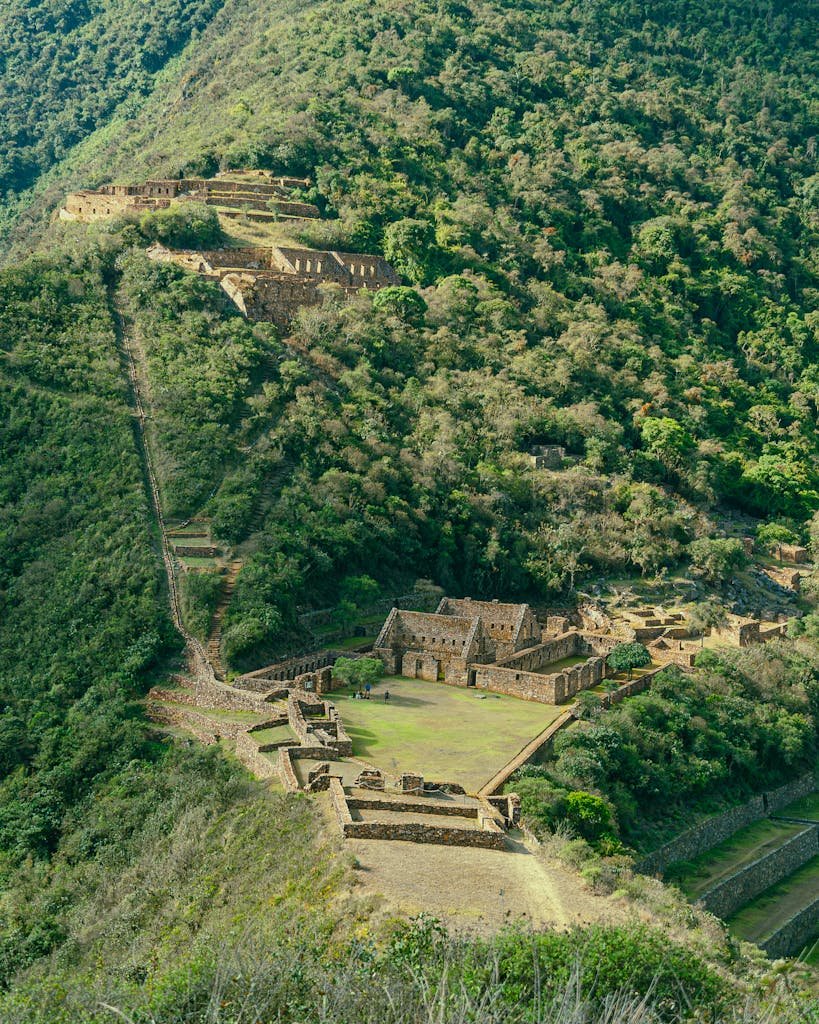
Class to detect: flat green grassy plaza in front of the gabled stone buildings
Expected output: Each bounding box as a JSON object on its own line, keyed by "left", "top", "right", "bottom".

{"left": 331, "top": 677, "right": 565, "bottom": 792}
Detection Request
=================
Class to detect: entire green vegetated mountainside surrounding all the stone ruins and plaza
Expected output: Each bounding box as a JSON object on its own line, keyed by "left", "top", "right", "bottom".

{"left": 0, "top": 0, "right": 819, "bottom": 1024}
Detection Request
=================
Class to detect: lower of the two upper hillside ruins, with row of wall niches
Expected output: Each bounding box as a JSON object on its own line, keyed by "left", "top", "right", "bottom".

{"left": 147, "top": 245, "right": 400, "bottom": 327}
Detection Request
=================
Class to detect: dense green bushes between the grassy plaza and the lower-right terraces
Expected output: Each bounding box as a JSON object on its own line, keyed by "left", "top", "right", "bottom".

{"left": 511, "top": 643, "right": 819, "bottom": 848}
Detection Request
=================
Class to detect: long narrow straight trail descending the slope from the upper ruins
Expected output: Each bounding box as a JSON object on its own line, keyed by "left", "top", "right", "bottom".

{"left": 109, "top": 290, "right": 216, "bottom": 684}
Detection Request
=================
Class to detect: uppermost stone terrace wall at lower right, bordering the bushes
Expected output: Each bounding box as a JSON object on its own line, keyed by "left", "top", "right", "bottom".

{"left": 635, "top": 773, "right": 816, "bottom": 874}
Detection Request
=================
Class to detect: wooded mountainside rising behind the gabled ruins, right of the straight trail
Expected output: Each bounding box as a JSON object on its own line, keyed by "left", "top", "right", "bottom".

{"left": 14, "top": 0, "right": 819, "bottom": 665}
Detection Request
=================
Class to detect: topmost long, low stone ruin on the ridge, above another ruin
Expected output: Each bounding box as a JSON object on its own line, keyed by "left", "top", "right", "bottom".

{"left": 59, "top": 172, "right": 319, "bottom": 223}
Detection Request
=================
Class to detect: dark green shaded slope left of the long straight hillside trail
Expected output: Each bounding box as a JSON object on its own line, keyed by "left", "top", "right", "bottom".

{"left": 0, "top": 251, "right": 173, "bottom": 864}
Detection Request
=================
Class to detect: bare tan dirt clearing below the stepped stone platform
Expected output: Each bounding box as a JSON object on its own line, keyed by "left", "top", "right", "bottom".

{"left": 347, "top": 840, "right": 619, "bottom": 934}
